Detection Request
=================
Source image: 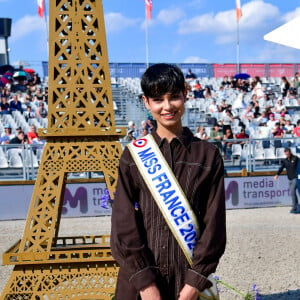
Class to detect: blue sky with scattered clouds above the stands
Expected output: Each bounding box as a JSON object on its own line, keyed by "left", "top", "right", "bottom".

{"left": 0, "top": 0, "right": 300, "bottom": 72}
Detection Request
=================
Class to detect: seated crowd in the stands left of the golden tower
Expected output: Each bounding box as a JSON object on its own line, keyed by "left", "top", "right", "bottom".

{"left": 0, "top": 67, "right": 48, "bottom": 164}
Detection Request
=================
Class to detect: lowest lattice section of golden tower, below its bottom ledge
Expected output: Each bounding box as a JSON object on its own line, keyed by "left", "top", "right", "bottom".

{"left": 1, "top": 262, "right": 118, "bottom": 300}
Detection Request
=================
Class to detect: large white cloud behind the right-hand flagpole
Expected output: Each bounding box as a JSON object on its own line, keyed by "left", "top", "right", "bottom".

{"left": 178, "top": 0, "right": 279, "bottom": 35}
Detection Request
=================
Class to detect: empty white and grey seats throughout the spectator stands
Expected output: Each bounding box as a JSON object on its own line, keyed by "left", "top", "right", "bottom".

{"left": 0, "top": 77, "right": 300, "bottom": 177}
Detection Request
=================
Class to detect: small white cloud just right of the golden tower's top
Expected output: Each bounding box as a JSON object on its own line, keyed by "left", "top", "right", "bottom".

{"left": 105, "top": 12, "right": 139, "bottom": 33}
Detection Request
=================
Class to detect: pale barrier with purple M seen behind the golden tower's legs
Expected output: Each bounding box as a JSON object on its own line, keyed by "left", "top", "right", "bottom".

{"left": 0, "top": 183, "right": 111, "bottom": 220}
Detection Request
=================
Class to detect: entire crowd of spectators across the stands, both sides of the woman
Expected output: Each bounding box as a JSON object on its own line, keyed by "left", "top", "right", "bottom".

{"left": 0, "top": 64, "right": 300, "bottom": 169}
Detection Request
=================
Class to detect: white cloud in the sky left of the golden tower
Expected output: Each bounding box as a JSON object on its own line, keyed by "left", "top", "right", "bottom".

{"left": 11, "top": 15, "right": 46, "bottom": 42}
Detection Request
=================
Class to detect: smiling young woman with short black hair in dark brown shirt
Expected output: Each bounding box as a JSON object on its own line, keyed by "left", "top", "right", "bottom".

{"left": 111, "top": 64, "right": 226, "bottom": 300}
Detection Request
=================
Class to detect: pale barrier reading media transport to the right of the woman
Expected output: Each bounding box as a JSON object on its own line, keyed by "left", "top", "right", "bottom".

{"left": 225, "top": 175, "right": 292, "bottom": 209}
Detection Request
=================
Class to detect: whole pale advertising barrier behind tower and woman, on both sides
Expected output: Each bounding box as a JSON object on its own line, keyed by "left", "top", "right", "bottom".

{"left": 0, "top": 175, "right": 291, "bottom": 220}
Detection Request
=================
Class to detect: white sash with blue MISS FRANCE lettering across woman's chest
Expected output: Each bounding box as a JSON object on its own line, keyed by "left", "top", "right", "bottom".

{"left": 127, "top": 134, "right": 219, "bottom": 300}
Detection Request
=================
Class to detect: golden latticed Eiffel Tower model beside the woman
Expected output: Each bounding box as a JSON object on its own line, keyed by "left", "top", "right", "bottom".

{"left": 1, "top": 0, "right": 124, "bottom": 300}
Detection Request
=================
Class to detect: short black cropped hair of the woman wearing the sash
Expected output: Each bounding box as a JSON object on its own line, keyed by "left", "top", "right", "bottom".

{"left": 141, "top": 63, "right": 186, "bottom": 98}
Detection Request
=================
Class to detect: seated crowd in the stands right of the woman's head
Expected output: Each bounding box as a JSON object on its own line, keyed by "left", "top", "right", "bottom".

{"left": 186, "top": 70, "right": 300, "bottom": 159}
